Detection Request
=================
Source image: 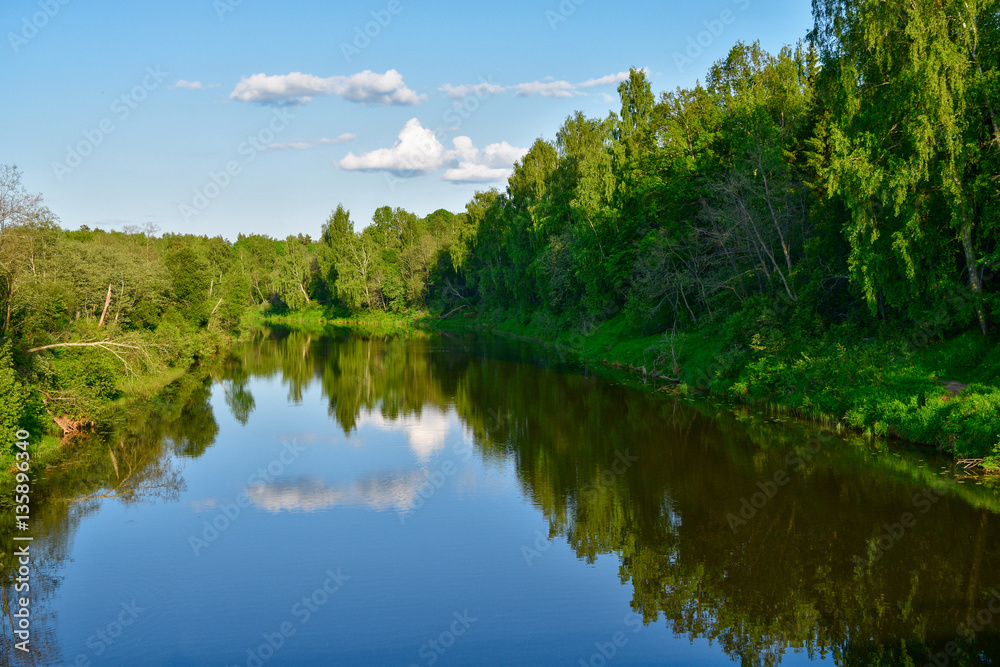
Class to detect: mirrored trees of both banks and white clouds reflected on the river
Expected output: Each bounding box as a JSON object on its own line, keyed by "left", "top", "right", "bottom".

{"left": 3, "top": 330, "right": 1000, "bottom": 665}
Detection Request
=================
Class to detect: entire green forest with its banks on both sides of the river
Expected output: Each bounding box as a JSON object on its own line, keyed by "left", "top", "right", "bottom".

{"left": 0, "top": 0, "right": 1000, "bottom": 469}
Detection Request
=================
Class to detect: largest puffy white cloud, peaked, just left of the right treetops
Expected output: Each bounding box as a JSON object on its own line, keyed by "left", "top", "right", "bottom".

{"left": 337, "top": 118, "right": 528, "bottom": 183}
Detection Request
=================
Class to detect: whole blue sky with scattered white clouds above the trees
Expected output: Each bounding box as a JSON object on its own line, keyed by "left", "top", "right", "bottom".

{"left": 0, "top": 0, "right": 811, "bottom": 239}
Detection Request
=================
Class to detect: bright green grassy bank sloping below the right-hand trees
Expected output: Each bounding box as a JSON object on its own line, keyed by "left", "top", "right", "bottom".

{"left": 434, "top": 314, "right": 1000, "bottom": 472}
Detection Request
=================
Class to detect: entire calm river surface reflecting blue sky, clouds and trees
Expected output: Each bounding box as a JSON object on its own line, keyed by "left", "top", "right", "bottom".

{"left": 0, "top": 331, "right": 1000, "bottom": 667}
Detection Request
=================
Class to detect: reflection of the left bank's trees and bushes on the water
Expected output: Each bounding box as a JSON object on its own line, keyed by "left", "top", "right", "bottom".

{"left": 0, "top": 373, "right": 218, "bottom": 666}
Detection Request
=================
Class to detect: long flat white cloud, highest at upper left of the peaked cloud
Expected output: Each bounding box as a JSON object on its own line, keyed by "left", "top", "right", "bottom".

{"left": 229, "top": 69, "right": 426, "bottom": 105}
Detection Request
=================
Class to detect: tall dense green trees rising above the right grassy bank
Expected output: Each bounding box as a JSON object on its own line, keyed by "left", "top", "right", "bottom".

{"left": 448, "top": 25, "right": 1000, "bottom": 332}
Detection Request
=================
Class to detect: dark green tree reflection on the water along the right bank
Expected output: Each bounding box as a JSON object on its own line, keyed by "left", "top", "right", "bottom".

{"left": 215, "top": 332, "right": 1000, "bottom": 665}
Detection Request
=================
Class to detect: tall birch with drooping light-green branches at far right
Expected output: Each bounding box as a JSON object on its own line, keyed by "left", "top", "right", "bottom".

{"left": 812, "top": 0, "right": 998, "bottom": 334}
